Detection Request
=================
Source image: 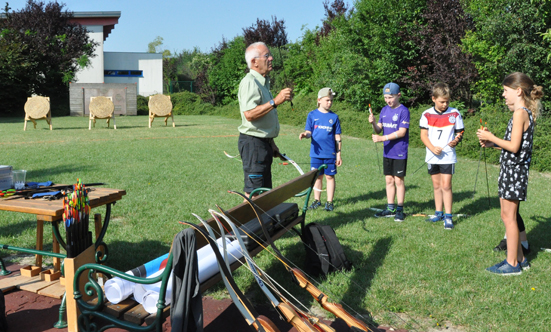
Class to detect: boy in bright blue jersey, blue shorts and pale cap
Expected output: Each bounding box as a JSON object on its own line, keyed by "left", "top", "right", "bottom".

{"left": 298, "top": 88, "right": 342, "bottom": 211}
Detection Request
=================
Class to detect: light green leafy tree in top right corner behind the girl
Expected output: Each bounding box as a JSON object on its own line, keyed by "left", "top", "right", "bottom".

{"left": 463, "top": 0, "right": 551, "bottom": 108}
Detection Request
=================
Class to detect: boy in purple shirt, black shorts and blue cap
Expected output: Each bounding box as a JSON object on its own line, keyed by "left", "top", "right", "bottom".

{"left": 369, "top": 82, "right": 409, "bottom": 221}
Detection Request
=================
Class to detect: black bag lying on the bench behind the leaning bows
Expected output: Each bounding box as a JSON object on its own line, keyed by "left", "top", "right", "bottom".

{"left": 229, "top": 203, "right": 298, "bottom": 251}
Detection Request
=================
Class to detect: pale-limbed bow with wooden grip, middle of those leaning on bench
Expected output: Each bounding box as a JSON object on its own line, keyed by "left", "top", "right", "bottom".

{"left": 209, "top": 209, "right": 335, "bottom": 332}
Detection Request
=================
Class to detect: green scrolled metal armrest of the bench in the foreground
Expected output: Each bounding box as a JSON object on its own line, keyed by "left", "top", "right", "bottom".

{"left": 73, "top": 253, "right": 172, "bottom": 332}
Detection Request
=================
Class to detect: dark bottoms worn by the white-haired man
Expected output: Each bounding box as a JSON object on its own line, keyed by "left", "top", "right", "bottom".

{"left": 237, "top": 134, "right": 274, "bottom": 193}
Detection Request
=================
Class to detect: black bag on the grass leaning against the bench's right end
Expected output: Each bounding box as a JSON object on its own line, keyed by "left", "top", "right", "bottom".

{"left": 302, "top": 223, "right": 352, "bottom": 275}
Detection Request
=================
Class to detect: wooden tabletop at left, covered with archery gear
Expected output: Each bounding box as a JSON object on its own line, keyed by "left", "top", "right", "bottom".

{"left": 0, "top": 187, "right": 126, "bottom": 221}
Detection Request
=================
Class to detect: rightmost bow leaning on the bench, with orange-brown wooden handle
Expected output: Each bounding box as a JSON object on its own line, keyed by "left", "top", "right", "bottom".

{"left": 224, "top": 191, "right": 372, "bottom": 332}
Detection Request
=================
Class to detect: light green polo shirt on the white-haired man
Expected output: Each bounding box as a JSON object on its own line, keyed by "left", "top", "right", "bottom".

{"left": 238, "top": 70, "right": 279, "bottom": 138}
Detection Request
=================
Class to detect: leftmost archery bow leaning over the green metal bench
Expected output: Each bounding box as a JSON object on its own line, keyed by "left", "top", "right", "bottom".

{"left": 180, "top": 221, "right": 279, "bottom": 332}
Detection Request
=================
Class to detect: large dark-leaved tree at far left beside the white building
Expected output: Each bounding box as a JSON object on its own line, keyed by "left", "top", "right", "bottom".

{"left": 0, "top": 0, "right": 96, "bottom": 112}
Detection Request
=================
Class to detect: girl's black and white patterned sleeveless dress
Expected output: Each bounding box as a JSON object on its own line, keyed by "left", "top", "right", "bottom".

{"left": 498, "top": 107, "right": 534, "bottom": 201}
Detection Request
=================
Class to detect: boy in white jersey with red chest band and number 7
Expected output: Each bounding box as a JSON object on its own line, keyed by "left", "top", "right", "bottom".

{"left": 419, "top": 83, "right": 465, "bottom": 229}
